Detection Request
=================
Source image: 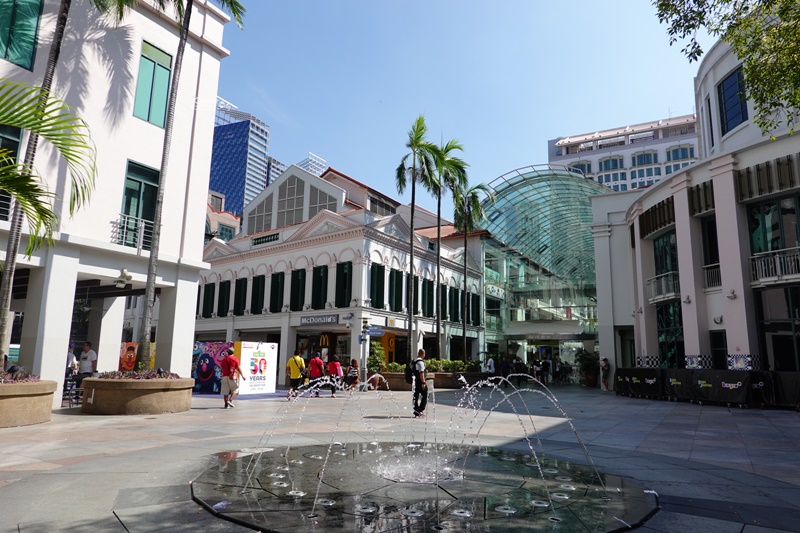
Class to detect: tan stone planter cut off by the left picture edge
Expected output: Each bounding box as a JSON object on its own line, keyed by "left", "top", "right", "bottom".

{"left": 0, "top": 381, "right": 58, "bottom": 428}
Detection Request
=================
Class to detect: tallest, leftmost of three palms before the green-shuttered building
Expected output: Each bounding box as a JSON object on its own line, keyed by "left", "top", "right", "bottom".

{"left": 395, "top": 115, "right": 436, "bottom": 361}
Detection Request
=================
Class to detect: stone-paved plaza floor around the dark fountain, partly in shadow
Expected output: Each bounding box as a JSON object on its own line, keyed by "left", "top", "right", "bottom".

{"left": 0, "top": 386, "right": 800, "bottom": 533}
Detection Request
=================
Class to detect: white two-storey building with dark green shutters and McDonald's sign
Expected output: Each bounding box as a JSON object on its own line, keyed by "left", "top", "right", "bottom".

{"left": 195, "top": 165, "right": 483, "bottom": 380}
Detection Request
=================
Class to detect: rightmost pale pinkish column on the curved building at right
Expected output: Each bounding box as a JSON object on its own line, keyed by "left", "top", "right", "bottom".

{"left": 709, "top": 155, "right": 758, "bottom": 355}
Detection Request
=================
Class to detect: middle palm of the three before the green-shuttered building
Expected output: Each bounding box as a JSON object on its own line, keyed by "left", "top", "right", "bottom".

{"left": 433, "top": 139, "right": 469, "bottom": 357}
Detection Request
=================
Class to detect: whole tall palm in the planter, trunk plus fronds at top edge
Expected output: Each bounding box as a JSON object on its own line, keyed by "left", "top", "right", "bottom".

{"left": 139, "top": 0, "right": 245, "bottom": 368}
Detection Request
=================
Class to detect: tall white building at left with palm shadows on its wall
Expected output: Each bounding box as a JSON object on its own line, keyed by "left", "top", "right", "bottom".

{"left": 0, "top": 0, "right": 234, "bottom": 401}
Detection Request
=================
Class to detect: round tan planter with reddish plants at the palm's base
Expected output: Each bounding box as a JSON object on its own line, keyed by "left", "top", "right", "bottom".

{"left": 81, "top": 378, "right": 194, "bottom": 415}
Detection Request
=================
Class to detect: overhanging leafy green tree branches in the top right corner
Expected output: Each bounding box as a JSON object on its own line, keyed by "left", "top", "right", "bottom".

{"left": 653, "top": 0, "right": 800, "bottom": 134}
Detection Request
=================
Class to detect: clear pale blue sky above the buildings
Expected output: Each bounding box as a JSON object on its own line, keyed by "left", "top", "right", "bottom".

{"left": 218, "top": 0, "right": 711, "bottom": 218}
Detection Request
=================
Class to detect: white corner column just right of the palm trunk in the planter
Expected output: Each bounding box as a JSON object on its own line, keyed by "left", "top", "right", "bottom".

{"left": 156, "top": 268, "right": 202, "bottom": 377}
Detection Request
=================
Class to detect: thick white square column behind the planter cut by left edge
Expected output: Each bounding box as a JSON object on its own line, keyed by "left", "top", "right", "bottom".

{"left": 19, "top": 245, "right": 79, "bottom": 409}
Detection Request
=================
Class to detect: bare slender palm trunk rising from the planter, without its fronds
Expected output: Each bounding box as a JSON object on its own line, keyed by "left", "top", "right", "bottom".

{"left": 139, "top": 0, "right": 194, "bottom": 370}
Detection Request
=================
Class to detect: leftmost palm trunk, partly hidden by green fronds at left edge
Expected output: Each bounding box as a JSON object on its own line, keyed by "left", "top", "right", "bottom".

{"left": 0, "top": 0, "right": 72, "bottom": 355}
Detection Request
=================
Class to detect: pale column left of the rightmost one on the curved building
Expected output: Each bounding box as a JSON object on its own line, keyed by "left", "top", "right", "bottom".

{"left": 670, "top": 172, "right": 711, "bottom": 356}
